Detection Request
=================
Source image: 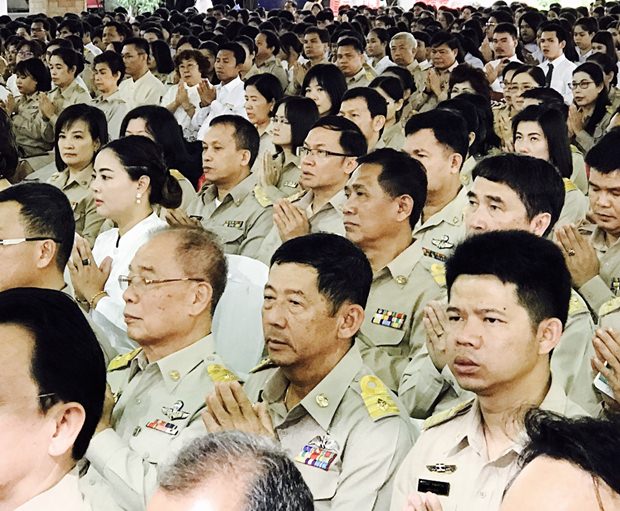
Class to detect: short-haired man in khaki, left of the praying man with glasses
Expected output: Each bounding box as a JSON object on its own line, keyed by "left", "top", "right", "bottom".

{"left": 168, "top": 115, "right": 273, "bottom": 258}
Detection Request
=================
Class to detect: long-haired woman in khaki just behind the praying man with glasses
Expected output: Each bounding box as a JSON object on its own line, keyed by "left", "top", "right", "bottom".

{"left": 256, "top": 96, "right": 319, "bottom": 202}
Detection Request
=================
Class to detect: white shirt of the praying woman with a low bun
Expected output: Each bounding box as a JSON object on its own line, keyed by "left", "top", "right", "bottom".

{"left": 93, "top": 213, "right": 168, "bottom": 338}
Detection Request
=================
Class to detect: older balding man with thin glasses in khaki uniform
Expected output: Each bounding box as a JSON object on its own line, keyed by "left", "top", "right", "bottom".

{"left": 82, "top": 228, "right": 235, "bottom": 510}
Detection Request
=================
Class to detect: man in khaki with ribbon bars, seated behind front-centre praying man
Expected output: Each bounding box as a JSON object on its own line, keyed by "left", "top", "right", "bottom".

{"left": 344, "top": 149, "right": 444, "bottom": 390}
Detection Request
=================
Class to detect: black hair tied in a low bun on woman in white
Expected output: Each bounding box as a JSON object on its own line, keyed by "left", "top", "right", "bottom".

{"left": 101, "top": 135, "right": 182, "bottom": 209}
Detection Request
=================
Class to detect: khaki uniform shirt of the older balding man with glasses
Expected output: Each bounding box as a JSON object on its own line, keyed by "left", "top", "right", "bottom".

{"left": 82, "top": 335, "right": 236, "bottom": 511}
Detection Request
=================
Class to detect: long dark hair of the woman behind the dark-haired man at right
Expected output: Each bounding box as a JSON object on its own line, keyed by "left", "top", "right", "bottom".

{"left": 512, "top": 105, "right": 573, "bottom": 178}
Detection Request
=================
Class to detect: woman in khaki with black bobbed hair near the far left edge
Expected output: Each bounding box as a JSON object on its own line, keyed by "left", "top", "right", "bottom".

{"left": 4, "top": 59, "right": 54, "bottom": 158}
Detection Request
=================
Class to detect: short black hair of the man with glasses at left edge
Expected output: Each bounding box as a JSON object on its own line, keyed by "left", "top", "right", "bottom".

{"left": 0, "top": 182, "right": 75, "bottom": 271}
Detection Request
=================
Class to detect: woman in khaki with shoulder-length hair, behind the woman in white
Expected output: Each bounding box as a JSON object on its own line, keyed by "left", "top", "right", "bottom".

{"left": 48, "top": 105, "right": 108, "bottom": 246}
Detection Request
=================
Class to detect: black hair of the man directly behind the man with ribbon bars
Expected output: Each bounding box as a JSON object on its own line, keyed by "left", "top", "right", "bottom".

{"left": 405, "top": 109, "right": 469, "bottom": 160}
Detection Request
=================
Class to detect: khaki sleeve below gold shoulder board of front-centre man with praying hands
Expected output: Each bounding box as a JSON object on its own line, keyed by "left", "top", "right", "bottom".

{"left": 331, "top": 418, "right": 414, "bottom": 511}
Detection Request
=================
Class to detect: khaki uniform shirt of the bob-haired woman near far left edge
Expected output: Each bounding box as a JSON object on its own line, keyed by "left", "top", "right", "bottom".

{"left": 11, "top": 92, "right": 54, "bottom": 157}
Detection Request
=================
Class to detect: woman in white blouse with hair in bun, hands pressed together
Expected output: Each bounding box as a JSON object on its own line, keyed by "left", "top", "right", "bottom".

{"left": 69, "top": 136, "right": 181, "bottom": 351}
